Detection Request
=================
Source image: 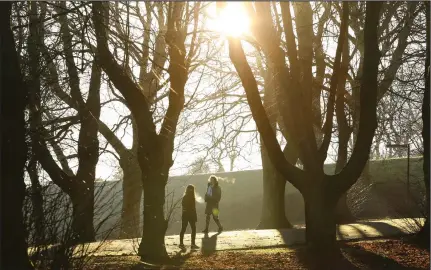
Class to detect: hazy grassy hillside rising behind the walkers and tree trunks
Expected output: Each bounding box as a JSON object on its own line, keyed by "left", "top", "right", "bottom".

{"left": 27, "top": 157, "right": 423, "bottom": 237}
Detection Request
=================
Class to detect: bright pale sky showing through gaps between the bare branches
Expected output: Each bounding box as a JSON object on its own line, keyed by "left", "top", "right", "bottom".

{"left": 32, "top": 2, "right": 424, "bottom": 184}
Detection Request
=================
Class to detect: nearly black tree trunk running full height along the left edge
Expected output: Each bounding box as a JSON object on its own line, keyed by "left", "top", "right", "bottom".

{"left": 0, "top": 2, "right": 33, "bottom": 270}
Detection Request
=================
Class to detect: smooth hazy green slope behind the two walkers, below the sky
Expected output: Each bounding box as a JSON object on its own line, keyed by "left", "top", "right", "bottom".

{"left": 33, "top": 158, "right": 422, "bottom": 238}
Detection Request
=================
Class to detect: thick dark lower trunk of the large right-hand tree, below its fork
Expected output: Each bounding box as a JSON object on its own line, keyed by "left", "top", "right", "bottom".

{"left": 304, "top": 183, "right": 339, "bottom": 269}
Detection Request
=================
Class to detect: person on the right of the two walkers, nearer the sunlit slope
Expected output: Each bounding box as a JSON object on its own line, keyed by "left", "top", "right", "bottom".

{"left": 202, "top": 175, "right": 223, "bottom": 234}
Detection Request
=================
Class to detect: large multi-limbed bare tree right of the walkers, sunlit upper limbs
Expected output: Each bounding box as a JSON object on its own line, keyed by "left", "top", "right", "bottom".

{"left": 229, "top": 2, "right": 381, "bottom": 261}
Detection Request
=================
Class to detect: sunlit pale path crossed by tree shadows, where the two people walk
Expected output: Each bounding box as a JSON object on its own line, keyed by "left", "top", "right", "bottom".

{"left": 78, "top": 218, "right": 424, "bottom": 256}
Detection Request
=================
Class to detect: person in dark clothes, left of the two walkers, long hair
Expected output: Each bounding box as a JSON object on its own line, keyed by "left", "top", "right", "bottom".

{"left": 180, "top": 185, "right": 199, "bottom": 249}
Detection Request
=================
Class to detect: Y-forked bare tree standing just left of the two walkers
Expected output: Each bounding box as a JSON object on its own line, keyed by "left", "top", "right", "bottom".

{"left": 93, "top": 2, "right": 199, "bottom": 259}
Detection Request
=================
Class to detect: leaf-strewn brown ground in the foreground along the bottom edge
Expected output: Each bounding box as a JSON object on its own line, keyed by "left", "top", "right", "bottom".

{"left": 85, "top": 238, "right": 430, "bottom": 270}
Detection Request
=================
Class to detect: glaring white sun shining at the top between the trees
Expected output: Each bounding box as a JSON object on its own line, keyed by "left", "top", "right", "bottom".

{"left": 210, "top": 2, "right": 250, "bottom": 37}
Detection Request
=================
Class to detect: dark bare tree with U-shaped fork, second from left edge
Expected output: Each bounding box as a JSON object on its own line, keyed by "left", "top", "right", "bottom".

{"left": 29, "top": 2, "right": 101, "bottom": 243}
